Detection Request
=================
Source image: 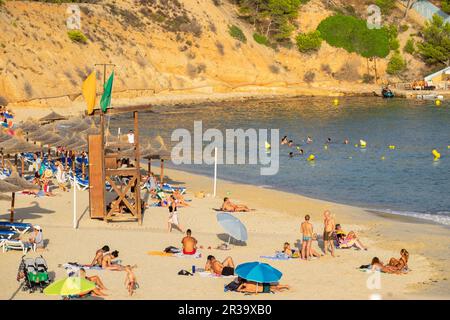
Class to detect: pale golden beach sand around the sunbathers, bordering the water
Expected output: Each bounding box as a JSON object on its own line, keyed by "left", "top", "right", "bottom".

{"left": 0, "top": 169, "right": 450, "bottom": 300}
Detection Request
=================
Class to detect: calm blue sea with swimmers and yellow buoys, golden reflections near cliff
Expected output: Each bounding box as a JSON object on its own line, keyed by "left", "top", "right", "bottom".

{"left": 110, "top": 98, "right": 450, "bottom": 224}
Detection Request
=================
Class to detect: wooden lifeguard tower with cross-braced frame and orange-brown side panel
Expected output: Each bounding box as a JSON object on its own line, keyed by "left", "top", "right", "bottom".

{"left": 88, "top": 105, "right": 149, "bottom": 225}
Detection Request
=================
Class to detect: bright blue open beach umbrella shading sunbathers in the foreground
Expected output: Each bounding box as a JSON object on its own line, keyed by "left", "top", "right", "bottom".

{"left": 236, "top": 261, "right": 283, "bottom": 283}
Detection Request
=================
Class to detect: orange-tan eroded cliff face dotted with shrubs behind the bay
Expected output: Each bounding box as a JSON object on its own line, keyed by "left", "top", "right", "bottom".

{"left": 0, "top": 0, "right": 420, "bottom": 106}
